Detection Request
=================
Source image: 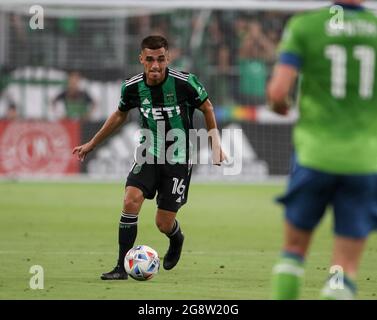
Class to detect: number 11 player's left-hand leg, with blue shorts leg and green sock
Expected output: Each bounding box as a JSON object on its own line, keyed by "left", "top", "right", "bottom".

{"left": 272, "top": 164, "right": 333, "bottom": 300}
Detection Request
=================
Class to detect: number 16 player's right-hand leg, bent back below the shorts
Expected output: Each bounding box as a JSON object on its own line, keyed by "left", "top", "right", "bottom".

{"left": 156, "top": 209, "right": 184, "bottom": 270}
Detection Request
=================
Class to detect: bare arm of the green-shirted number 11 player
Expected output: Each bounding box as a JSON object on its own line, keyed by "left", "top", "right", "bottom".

{"left": 267, "top": 63, "right": 298, "bottom": 115}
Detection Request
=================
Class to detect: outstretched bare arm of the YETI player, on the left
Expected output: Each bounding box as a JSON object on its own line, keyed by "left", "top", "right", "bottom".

{"left": 72, "top": 110, "right": 128, "bottom": 161}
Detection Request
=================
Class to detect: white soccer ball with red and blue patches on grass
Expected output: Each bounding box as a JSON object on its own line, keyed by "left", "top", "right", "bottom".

{"left": 124, "top": 245, "right": 160, "bottom": 281}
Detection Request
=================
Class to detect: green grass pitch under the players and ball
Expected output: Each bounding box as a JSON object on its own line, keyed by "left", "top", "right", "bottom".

{"left": 0, "top": 182, "right": 377, "bottom": 300}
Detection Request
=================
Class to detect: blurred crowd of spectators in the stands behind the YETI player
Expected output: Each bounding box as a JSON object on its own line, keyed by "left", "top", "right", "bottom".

{"left": 0, "top": 10, "right": 289, "bottom": 120}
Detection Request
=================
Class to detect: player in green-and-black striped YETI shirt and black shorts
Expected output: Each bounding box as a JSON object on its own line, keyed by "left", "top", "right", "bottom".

{"left": 73, "top": 35, "right": 226, "bottom": 280}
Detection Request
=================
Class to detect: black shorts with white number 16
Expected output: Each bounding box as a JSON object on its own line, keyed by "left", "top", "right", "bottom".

{"left": 126, "top": 163, "right": 191, "bottom": 212}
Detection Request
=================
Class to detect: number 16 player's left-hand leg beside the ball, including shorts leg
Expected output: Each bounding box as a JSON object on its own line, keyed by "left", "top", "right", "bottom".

{"left": 101, "top": 164, "right": 156, "bottom": 280}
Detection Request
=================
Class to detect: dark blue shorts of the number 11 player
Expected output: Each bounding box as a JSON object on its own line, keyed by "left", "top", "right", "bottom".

{"left": 277, "top": 161, "right": 377, "bottom": 238}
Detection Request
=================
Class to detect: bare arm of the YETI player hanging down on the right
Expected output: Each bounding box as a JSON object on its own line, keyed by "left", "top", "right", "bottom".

{"left": 199, "top": 99, "right": 227, "bottom": 165}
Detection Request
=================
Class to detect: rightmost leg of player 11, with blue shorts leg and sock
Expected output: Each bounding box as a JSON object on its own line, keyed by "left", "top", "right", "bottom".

{"left": 321, "top": 175, "right": 377, "bottom": 300}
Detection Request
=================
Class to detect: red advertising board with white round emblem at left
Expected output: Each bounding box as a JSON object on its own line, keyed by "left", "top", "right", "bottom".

{"left": 0, "top": 121, "right": 80, "bottom": 175}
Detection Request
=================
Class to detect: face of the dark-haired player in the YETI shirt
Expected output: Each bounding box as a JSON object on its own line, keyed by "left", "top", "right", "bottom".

{"left": 139, "top": 48, "right": 169, "bottom": 85}
